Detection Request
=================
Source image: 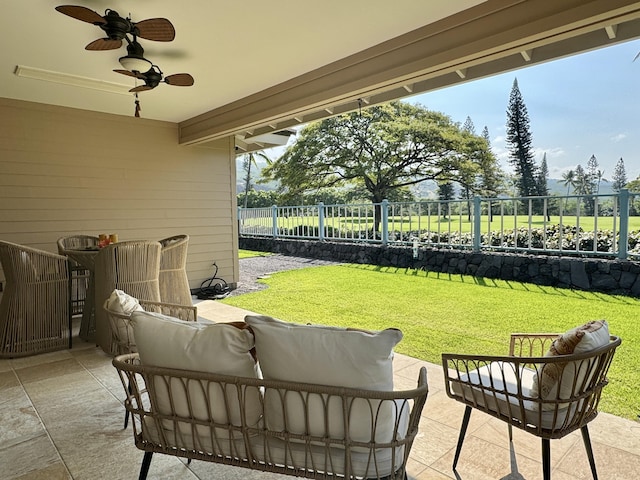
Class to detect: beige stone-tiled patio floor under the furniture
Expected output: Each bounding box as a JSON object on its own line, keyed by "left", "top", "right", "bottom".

{"left": 0, "top": 301, "right": 640, "bottom": 480}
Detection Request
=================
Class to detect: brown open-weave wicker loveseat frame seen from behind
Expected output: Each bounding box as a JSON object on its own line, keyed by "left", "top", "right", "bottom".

{"left": 113, "top": 354, "right": 428, "bottom": 479}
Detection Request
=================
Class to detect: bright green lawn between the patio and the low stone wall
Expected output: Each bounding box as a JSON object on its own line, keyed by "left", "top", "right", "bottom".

{"left": 223, "top": 265, "right": 640, "bottom": 419}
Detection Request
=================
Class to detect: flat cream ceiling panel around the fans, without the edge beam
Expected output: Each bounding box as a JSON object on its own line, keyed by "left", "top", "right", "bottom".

{"left": 0, "top": 0, "right": 482, "bottom": 122}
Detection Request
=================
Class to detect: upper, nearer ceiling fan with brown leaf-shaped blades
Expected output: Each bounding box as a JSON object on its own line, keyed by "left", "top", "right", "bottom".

{"left": 56, "top": 5, "right": 176, "bottom": 50}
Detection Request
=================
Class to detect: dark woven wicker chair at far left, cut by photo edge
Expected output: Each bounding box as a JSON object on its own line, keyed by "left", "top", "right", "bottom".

{"left": 0, "top": 241, "right": 71, "bottom": 358}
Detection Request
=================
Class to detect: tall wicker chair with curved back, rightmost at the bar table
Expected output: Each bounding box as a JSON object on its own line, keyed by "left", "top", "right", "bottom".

{"left": 159, "top": 235, "right": 193, "bottom": 305}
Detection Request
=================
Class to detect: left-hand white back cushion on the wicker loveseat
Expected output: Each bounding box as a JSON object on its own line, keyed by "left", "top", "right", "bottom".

{"left": 131, "top": 312, "right": 261, "bottom": 425}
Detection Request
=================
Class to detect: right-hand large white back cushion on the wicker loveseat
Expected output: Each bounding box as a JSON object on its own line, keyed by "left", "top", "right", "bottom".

{"left": 245, "top": 315, "right": 402, "bottom": 442}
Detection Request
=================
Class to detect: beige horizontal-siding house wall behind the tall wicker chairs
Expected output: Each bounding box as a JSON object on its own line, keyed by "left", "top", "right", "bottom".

{"left": 0, "top": 99, "right": 238, "bottom": 288}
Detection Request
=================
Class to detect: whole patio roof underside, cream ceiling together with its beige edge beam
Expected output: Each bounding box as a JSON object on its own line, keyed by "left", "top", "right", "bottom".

{"left": 5, "top": 0, "right": 640, "bottom": 151}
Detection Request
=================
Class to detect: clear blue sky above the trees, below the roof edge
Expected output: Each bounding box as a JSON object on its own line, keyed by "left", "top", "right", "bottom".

{"left": 405, "top": 41, "right": 640, "bottom": 180}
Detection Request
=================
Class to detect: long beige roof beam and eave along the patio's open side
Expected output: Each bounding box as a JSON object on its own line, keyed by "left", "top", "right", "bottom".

{"left": 179, "top": 0, "right": 640, "bottom": 147}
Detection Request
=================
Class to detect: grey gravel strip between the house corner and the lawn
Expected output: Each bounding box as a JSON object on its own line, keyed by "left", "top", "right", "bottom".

{"left": 229, "top": 254, "right": 339, "bottom": 297}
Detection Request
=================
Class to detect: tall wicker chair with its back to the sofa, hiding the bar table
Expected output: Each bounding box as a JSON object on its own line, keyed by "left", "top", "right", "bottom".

{"left": 95, "top": 240, "right": 161, "bottom": 353}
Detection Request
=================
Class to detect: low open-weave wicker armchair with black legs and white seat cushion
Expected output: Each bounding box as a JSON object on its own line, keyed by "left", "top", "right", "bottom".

{"left": 442, "top": 334, "right": 621, "bottom": 480}
